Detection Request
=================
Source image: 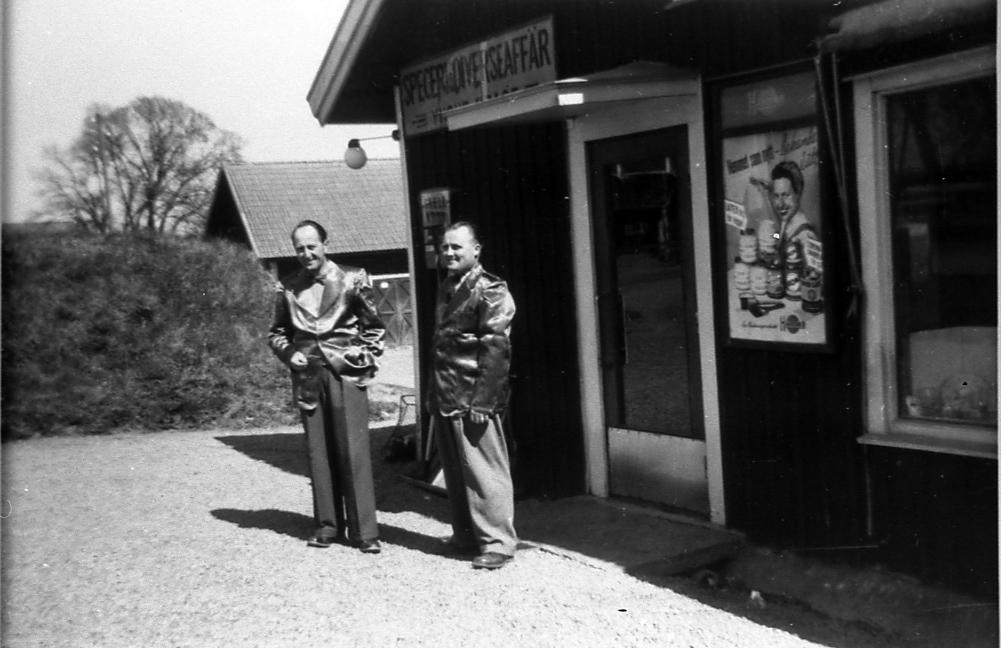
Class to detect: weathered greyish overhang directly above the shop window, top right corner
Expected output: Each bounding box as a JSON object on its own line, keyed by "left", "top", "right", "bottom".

{"left": 818, "top": 0, "right": 997, "bottom": 52}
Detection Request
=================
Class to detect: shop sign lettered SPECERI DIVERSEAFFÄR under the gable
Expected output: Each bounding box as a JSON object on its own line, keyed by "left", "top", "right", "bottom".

{"left": 399, "top": 16, "right": 557, "bottom": 136}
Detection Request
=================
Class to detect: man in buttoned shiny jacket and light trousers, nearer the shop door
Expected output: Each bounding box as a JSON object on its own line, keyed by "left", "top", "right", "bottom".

{"left": 426, "top": 221, "right": 518, "bottom": 569}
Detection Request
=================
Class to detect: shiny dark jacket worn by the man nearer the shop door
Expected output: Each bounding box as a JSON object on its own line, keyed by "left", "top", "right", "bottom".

{"left": 425, "top": 263, "right": 515, "bottom": 417}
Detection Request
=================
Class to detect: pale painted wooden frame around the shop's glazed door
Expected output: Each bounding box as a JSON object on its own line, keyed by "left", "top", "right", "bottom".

{"left": 567, "top": 88, "right": 726, "bottom": 525}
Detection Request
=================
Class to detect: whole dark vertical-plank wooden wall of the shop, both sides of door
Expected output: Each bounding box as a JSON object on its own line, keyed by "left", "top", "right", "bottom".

{"left": 380, "top": 0, "right": 997, "bottom": 588}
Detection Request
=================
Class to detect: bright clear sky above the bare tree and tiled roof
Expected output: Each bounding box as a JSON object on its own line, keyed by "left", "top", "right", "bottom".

{"left": 0, "top": 0, "right": 399, "bottom": 221}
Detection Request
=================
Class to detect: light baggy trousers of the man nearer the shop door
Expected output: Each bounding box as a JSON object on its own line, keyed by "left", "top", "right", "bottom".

{"left": 434, "top": 415, "right": 518, "bottom": 556}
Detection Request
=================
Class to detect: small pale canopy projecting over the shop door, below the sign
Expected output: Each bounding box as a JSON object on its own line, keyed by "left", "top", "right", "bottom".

{"left": 442, "top": 61, "right": 699, "bottom": 130}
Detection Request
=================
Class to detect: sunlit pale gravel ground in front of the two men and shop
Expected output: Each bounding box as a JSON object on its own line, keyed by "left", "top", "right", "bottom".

{"left": 2, "top": 428, "right": 853, "bottom": 648}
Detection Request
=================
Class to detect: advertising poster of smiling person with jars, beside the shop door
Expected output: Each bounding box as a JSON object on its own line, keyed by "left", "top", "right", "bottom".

{"left": 722, "top": 125, "right": 828, "bottom": 347}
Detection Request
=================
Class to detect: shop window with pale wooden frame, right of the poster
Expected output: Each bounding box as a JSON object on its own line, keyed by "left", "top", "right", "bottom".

{"left": 855, "top": 52, "right": 998, "bottom": 456}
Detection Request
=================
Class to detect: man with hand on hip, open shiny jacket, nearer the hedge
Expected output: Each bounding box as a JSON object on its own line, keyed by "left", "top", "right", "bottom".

{"left": 268, "top": 220, "right": 385, "bottom": 553}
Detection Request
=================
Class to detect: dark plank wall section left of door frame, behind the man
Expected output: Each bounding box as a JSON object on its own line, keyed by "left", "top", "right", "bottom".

{"left": 406, "top": 123, "right": 585, "bottom": 497}
